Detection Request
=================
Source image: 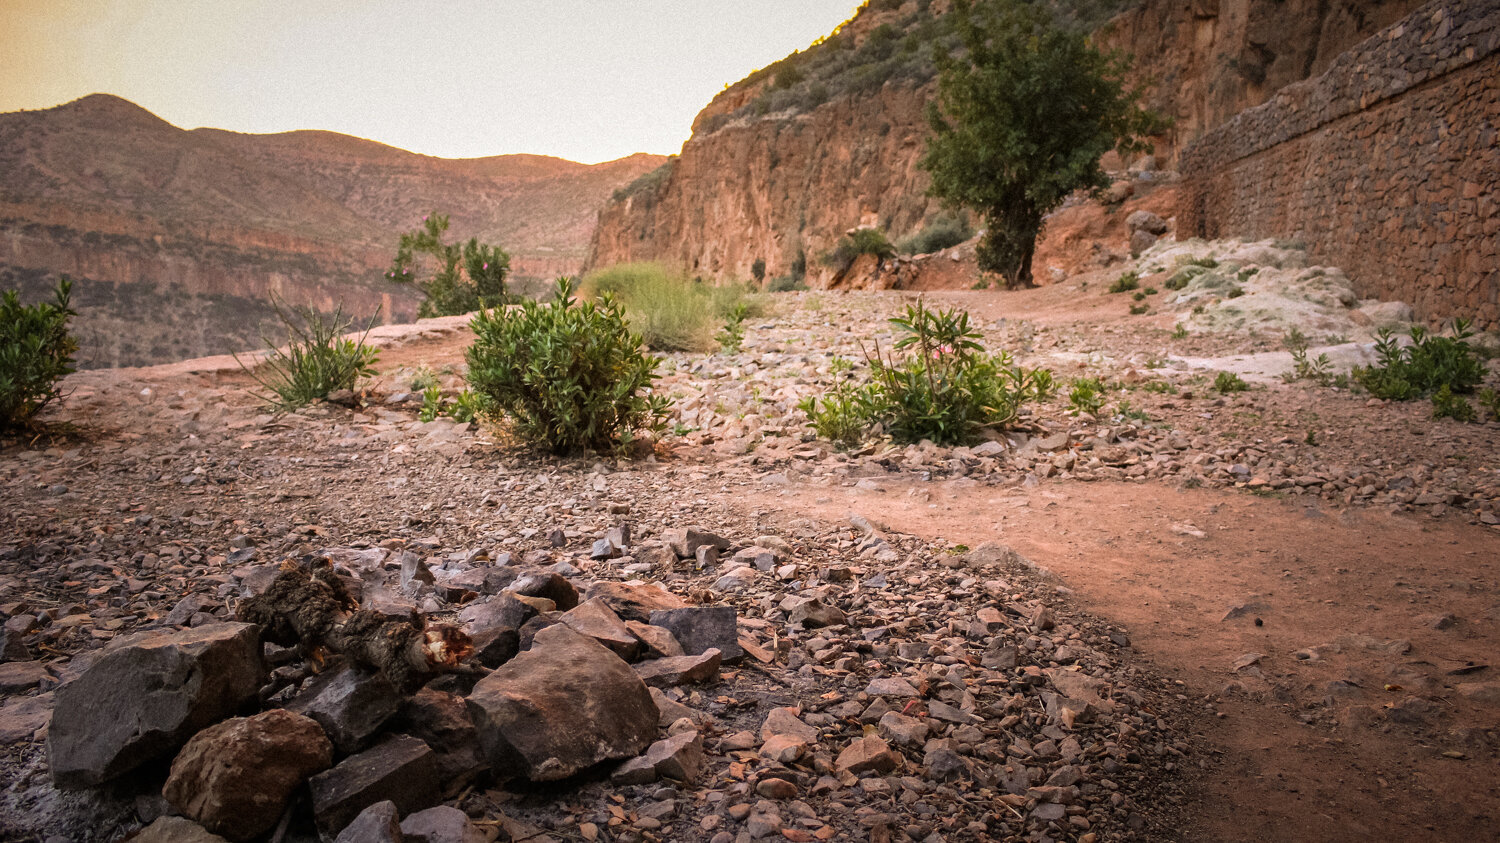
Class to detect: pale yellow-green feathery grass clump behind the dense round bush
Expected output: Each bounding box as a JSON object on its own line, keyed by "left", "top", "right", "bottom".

{"left": 582, "top": 263, "right": 759, "bottom": 351}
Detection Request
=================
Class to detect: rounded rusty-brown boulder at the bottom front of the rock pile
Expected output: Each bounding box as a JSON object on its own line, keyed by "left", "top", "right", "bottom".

{"left": 162, "top": 708, "right": 333, "bottom": 842}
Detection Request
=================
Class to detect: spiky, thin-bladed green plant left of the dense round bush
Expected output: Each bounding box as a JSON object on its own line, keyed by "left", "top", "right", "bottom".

{"left": 236, "top": 300, "right": 380, "bottom": 413}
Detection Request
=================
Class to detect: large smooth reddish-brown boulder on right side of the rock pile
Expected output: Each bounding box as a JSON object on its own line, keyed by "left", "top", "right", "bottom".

{"left": 468, "top": 624, "right": 659, "bottom": 782}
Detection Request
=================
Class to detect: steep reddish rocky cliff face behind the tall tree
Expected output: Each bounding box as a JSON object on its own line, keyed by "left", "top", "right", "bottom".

{"left": 588, "top": 0, "right": 1419, "bottom": 287}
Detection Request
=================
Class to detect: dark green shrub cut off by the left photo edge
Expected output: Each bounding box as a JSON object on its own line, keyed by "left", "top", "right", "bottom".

{"left": 0, "top": 278, "right": 78, "bottom": 429}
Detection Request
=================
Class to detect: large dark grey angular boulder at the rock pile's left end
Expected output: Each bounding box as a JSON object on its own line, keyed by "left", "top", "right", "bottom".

{"left": 47, "top": 624, "right": 266, "bottom": 789}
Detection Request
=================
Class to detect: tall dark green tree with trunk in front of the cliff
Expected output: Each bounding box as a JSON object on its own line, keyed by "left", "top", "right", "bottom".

{"left": 921, "top": 0, "right": 1163, "bottom": 287}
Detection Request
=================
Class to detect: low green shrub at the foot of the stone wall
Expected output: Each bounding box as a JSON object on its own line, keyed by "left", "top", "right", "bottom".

{"left": 1352, "top": 320, "right": 1485, "bottom": 401}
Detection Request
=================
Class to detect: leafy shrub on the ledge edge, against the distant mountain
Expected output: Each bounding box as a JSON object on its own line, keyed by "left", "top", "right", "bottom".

{"left": 386, "top": 213, "right": 510, "bottom": 318}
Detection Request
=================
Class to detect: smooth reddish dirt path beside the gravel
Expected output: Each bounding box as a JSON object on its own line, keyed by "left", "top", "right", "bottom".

{"left": 746, "top": 482, "right": 1500, "bottom": 840}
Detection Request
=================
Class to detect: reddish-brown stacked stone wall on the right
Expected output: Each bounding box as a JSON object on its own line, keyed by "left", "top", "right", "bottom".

{"left": 1178, "top": 0, "right": 1500, "bottom": 329}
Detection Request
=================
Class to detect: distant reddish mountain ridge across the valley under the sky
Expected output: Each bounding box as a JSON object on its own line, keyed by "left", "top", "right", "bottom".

{"left": 0, "top": 95, "right": 665, "bottom": 366}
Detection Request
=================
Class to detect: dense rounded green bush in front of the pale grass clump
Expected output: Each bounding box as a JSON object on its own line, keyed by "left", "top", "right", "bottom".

{"left": 467, "top": 278, "right": 668, "bottom": 455}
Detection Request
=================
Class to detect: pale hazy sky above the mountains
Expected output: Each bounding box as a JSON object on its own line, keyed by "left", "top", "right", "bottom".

{"left": 0, "top": 0, "right": 858, "bottom": 164}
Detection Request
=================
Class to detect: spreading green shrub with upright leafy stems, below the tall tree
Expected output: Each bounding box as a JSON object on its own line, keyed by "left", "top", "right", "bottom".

{"left": 800, "top": 302, "right": 1053, "bottom": 444}
